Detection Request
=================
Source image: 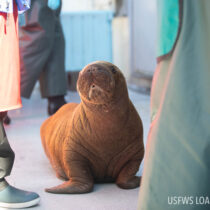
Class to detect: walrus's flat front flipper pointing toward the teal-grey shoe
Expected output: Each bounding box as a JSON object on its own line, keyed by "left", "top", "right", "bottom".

{"left": 45, "top": 180, "right": 93, "bottom": 194}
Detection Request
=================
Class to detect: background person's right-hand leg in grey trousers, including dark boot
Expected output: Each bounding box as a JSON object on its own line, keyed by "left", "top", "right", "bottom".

{"left": 40, "top": 8, "right": 67, "bottom": 115}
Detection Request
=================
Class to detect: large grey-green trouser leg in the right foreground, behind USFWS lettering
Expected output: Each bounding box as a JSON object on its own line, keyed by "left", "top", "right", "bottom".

{"left": 138, "top": 0, "right": 210, "bottom": 210}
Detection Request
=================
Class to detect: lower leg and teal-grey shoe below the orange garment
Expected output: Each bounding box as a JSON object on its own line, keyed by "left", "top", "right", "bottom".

{"left": 0, "top": 112, "right": 40, "bottom": 208}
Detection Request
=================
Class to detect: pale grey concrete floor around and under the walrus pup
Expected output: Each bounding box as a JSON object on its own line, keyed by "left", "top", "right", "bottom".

{"left": 6, "top": 87, "right": 150, "bottom": 210}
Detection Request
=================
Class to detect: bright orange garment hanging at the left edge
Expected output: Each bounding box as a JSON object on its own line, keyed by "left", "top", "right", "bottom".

{"left": 0, "top": 3, "right": 22, "bottom": 112}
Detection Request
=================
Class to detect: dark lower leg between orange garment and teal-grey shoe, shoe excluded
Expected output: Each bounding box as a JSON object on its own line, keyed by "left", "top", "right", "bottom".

{"left": 0, "top": 116, "right": 15, "bottom": 179}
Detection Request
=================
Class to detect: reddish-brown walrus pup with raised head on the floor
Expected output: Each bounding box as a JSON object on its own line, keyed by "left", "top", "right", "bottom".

{"left": 41, "top": 61, "right": 144, "bottom": 194}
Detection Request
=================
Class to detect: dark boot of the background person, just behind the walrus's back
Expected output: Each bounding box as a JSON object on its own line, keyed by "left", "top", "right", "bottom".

{"left": 48, "top": 96, "right": 66, "bottom": 115}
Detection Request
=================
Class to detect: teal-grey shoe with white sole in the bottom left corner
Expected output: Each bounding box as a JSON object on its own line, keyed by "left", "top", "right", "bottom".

{"left": 0, "top": 181, "right": 40, "bottom": 209}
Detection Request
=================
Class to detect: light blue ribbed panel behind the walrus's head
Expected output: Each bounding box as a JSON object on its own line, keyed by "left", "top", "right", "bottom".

{"left": 61, "top": 11, "right": 113, "bottom": 71}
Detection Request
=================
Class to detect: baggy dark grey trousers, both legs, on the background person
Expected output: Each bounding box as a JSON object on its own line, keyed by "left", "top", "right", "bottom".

{"left": 19, "top": 0, "right": 67, "bottom": 98}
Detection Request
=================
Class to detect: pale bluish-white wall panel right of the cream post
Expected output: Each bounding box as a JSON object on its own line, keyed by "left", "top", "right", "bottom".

{"left": 130, "top": 0, "right": 157, "bottom": 75}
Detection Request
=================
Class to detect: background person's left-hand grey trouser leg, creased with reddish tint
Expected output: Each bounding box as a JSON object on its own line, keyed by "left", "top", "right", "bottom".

{"left": 19, "top": 0, "right": 55, "bottom": 98}
